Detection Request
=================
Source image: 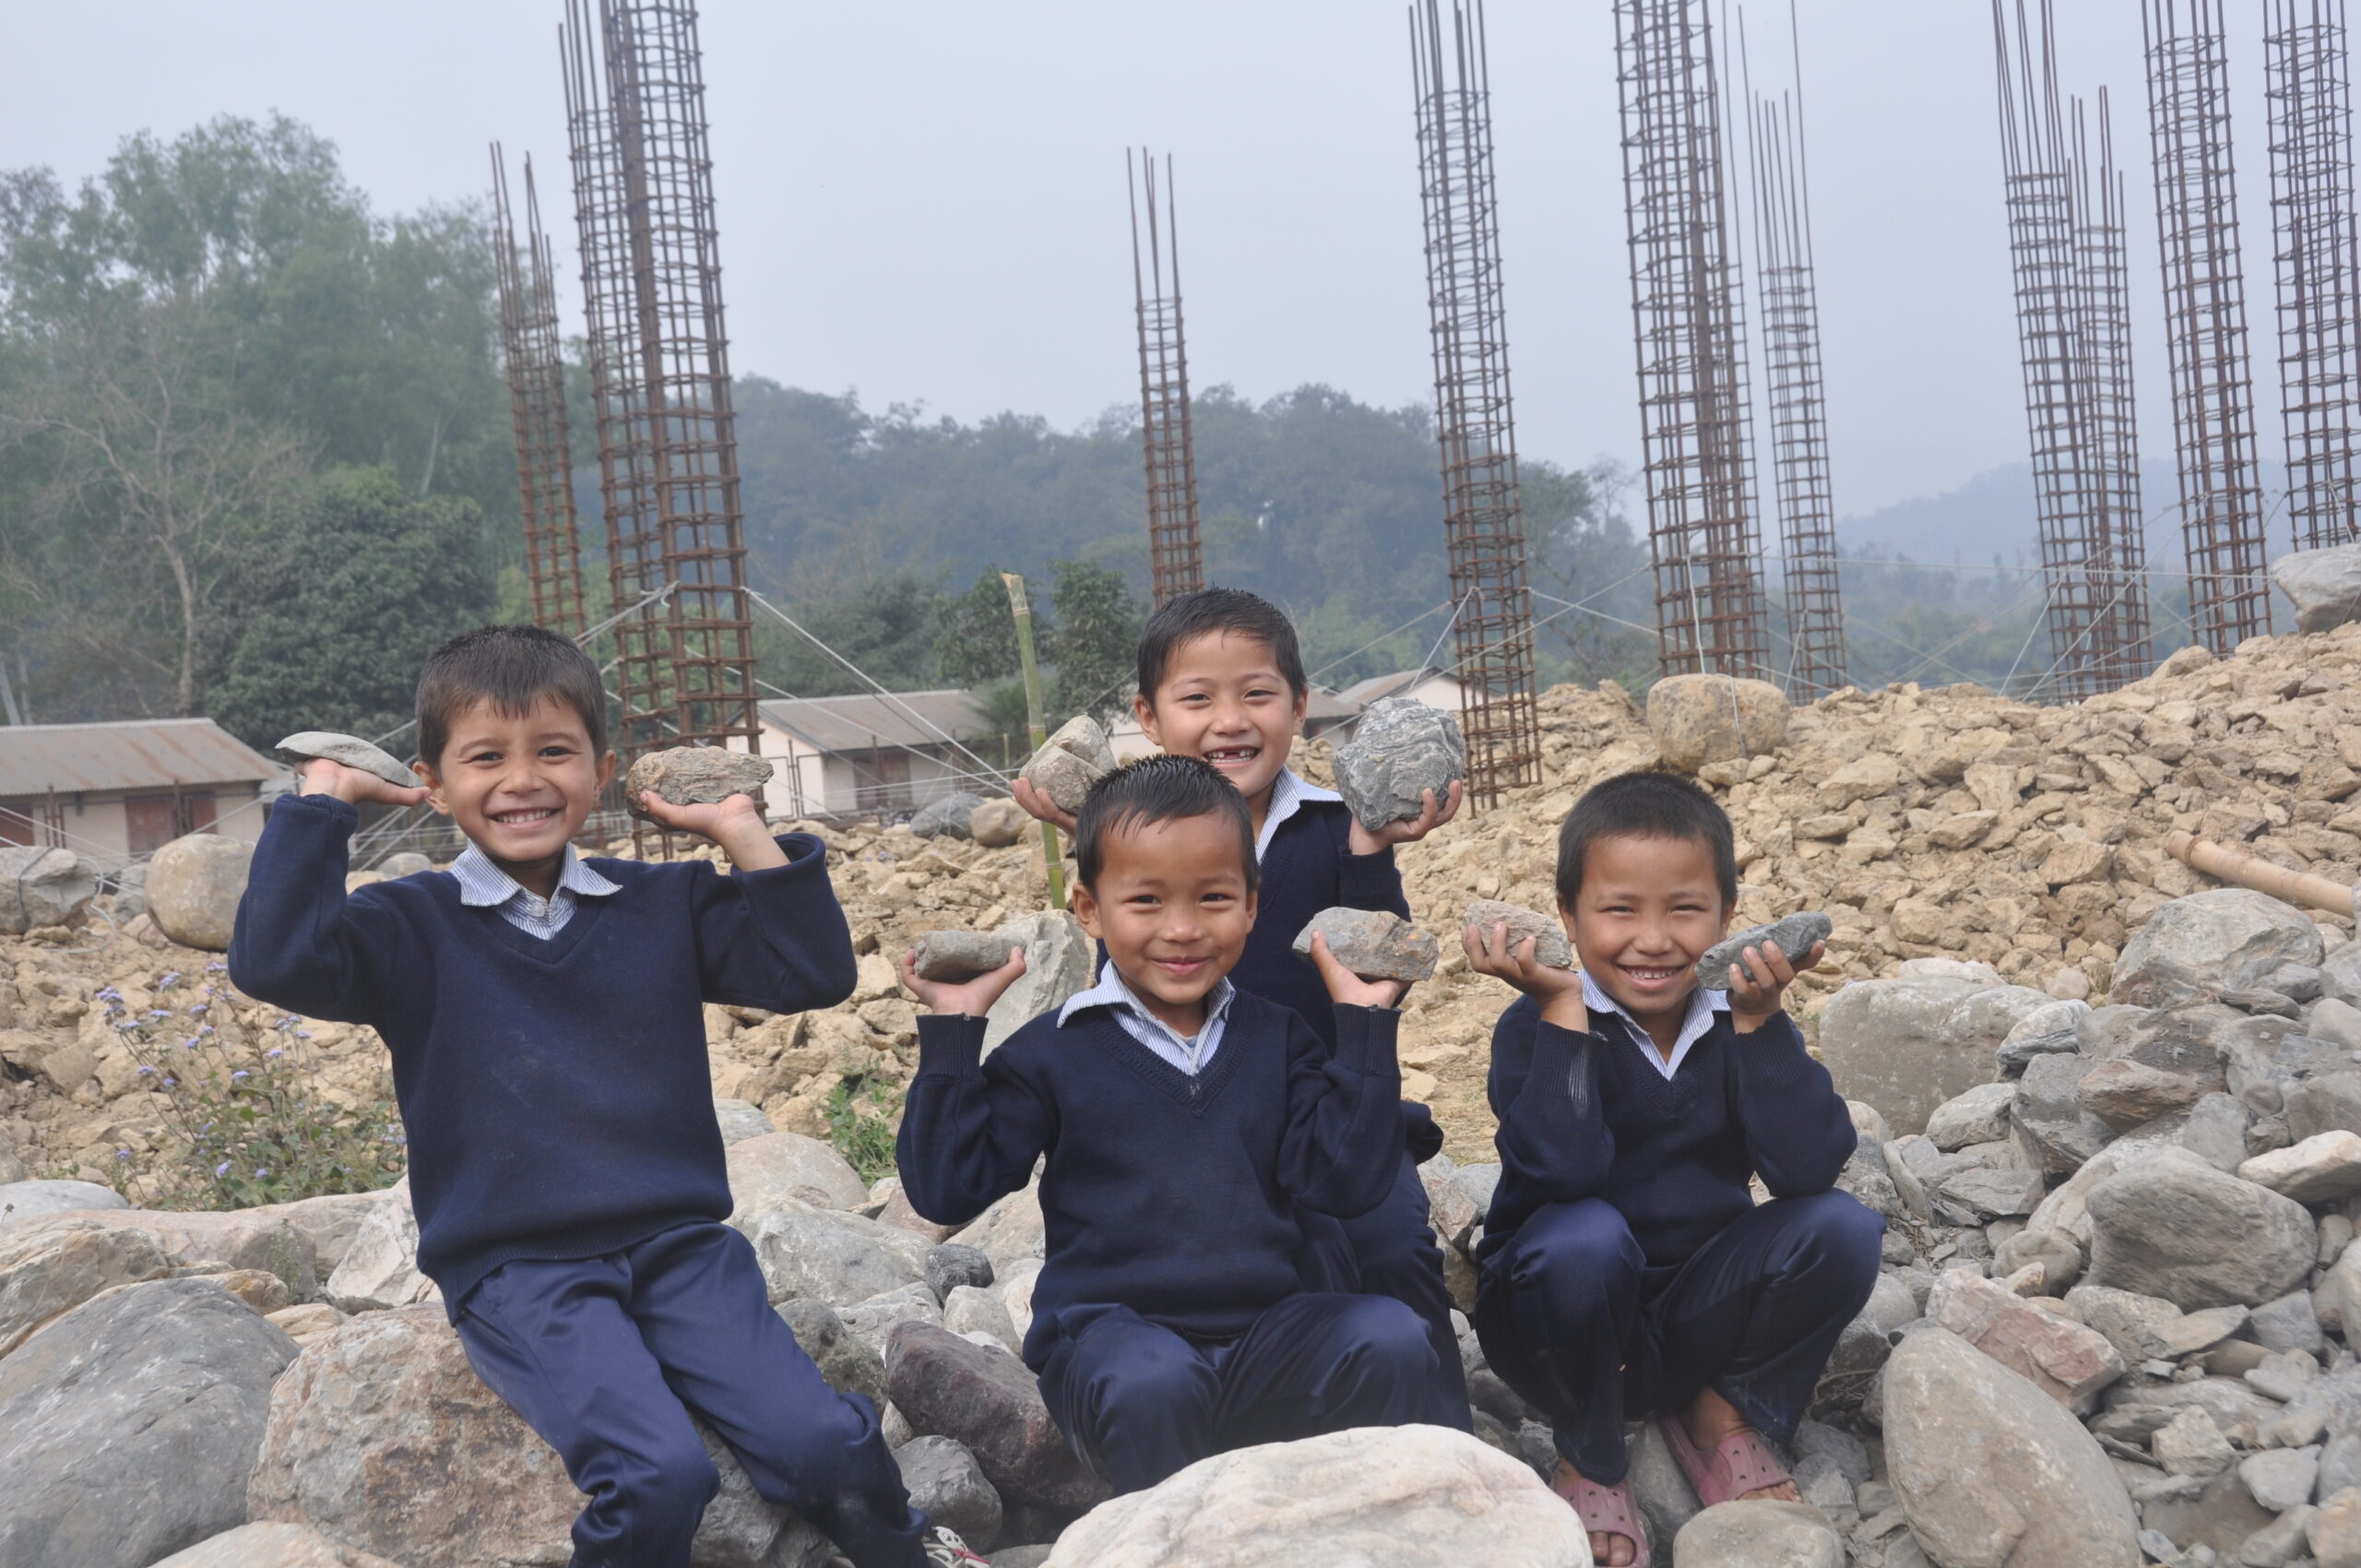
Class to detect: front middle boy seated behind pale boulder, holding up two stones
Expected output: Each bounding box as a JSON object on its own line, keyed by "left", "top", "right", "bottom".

{"left": 895, "top": 755, "right": 1433, "bottom": 1492}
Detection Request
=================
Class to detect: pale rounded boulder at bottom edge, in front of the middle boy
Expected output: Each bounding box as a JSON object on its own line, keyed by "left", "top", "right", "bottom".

{"left": 1044, "top": 1426, "right": 1591, "bottom": 1568}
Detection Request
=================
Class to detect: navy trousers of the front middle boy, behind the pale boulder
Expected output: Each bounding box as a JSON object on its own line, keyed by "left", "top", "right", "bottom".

{"left": 1041, "top": 1291, "right": 1435, "bottom": 1492}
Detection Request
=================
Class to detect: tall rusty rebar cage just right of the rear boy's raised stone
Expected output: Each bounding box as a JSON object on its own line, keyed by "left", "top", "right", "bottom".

{"left": 1409, "top": 0, "right": 1542, "bottom": 805}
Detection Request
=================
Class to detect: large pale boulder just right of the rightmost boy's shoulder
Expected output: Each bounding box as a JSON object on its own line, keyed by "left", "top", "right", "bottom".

{"left": 1821, "top": 973, "right": 2054, "bottom": 1135}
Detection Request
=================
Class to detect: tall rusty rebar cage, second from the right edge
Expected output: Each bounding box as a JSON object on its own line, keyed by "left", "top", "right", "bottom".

{"left": 2139, "top": 0, "right": 2272, "bottom": 654}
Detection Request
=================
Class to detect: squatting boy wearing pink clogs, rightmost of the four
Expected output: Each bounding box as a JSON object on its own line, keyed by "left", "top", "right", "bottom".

{"left": 1464, "top": 772, "right": 1884, "bottom": 1568}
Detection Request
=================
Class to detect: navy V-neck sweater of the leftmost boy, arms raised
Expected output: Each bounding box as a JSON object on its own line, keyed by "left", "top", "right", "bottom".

{"left": 229, "top": 796, "right": 855, "bottom": 1315}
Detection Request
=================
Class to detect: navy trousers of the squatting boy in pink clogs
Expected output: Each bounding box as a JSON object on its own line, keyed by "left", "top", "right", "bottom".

{"left": 1476, "top": 1193, "right": 1886, "bottom": 1485}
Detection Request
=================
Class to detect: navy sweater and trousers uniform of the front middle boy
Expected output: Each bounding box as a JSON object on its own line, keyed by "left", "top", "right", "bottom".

{"left": 895, "top": 992, "right": 1433, "bottom": 1492}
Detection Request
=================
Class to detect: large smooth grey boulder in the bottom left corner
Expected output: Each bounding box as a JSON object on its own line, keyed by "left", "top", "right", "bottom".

{"left": 0, "top": 1280, "right": 295, "bottom": 1568}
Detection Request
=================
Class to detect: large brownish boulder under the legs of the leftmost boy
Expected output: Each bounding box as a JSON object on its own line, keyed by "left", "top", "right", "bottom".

{"left": 245, "top": 1308, "right": 829, "bottom": 1568}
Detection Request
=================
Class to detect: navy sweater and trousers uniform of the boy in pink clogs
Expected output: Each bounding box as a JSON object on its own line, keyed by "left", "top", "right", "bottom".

{"left": 1476, "top": 980, "right": 1884, "bottom": 1485}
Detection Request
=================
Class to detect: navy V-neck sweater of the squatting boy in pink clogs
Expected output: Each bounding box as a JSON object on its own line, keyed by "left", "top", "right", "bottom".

{"left": 1483, "top": 996, "right": 1854, "bottom": 1268}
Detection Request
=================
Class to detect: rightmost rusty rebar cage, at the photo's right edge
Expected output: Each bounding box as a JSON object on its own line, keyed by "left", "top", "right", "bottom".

{"left": 2261, "top": 0, "right": 2361, "bottom": 551}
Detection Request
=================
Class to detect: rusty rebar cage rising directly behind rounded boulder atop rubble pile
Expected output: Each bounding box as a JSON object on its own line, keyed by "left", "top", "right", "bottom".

{"left": 1615, "top": 0, "right": 1778, "bottom": 680}
